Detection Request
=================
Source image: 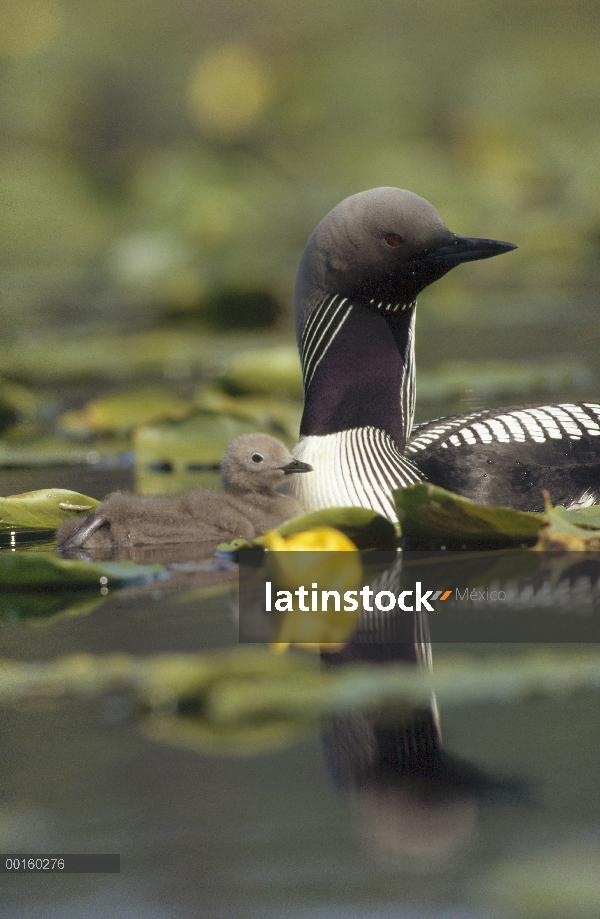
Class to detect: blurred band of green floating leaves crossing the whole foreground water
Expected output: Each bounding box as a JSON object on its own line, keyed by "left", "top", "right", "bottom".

{"left": 0, "top": 648, "right": 600, "bottom": 755}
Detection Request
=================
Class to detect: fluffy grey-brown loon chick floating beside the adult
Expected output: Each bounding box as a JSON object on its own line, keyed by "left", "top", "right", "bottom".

{"left": 57, "top": 434, "right": 312, "bottom": 550}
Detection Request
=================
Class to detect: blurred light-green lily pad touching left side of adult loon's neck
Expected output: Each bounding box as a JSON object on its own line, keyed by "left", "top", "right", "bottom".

{"left": 221, "top": 345, "right": 303, "bottom": 399}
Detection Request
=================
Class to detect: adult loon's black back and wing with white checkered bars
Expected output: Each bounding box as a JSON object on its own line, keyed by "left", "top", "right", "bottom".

{"left": 406, "top": 402, "right": 600, "bottom": 511}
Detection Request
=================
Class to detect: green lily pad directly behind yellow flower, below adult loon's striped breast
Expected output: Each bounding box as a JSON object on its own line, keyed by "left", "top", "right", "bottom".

{"left": 217, "top": 507, "right": 398, "bottom": 554}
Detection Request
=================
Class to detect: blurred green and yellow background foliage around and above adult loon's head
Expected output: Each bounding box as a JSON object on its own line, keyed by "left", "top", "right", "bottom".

{"left": 0, "top": 0, "right": 600, "bottom": 335}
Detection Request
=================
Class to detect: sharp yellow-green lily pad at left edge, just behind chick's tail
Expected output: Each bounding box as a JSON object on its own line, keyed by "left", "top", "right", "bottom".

{"left": 0, "top": 488, "right": 100, "bottom": 529}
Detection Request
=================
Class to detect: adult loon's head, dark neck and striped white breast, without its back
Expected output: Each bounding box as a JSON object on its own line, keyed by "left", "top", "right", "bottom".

{"left": 291, "top": 188, "right": 516, "bottom": 520}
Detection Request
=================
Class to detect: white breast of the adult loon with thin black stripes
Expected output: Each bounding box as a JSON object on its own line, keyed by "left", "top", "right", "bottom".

{"left": 290, "top": 427, "right": 423, "bottom": 521}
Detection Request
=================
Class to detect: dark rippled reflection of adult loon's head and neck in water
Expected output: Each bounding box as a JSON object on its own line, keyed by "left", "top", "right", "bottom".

{"left": 322, "top": 644, "right": 529, "bottom": 870}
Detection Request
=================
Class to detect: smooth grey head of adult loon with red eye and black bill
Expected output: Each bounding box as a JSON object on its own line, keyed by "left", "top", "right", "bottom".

{"left": 295, "top": 187, "right": 517, "bottom": 339}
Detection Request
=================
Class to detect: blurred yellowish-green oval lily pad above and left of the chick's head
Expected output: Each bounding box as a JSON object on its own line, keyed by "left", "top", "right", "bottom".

{"left": 59, "top": 386, "right": 194, "bottom": 437}
